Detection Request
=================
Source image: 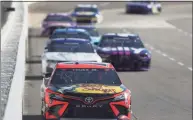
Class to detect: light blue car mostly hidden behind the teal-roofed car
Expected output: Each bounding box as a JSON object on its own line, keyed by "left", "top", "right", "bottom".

{"left": 65, "top": 24, "right": 101, "bottom": 45}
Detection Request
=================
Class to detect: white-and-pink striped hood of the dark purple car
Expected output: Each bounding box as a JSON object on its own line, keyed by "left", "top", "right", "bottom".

{"left": 97, "top": 47, "right": 149, "bottom": 54}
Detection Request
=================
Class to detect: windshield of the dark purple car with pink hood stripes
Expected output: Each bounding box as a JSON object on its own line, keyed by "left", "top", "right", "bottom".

{"left": 99, "top": 36, "right": 144, "bottom": 48}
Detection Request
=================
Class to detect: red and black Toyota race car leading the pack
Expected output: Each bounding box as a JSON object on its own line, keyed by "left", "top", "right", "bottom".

{"left": 40, "top": 62, "right": 132, "bottom": 120}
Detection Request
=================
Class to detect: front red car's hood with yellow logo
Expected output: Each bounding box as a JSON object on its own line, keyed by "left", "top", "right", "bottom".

{"left": 50, "top": 84, "right": 126, "bottom": 94}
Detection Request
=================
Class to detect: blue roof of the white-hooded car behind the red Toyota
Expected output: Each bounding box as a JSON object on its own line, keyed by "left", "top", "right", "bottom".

{"left": 50, "top": 38, "right": 90, "bottom": 43}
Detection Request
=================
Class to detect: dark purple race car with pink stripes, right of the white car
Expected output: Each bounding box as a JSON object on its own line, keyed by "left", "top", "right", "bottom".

{"left": 97, "top": 33, "right": 151, "bottom": 70}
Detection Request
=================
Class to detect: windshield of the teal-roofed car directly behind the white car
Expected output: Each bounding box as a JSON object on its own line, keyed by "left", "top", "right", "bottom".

{"left": 50, "top": 32, "right": 91, "bottom": 40}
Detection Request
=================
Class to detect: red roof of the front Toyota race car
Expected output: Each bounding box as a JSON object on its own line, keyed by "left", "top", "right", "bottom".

{"left": 56, "top": 61, "right": 114, "bottom": 69}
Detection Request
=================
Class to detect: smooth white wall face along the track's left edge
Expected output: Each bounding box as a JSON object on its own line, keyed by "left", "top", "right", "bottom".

{"left": 3, "top": 2, "right": 28, "bottom": 120}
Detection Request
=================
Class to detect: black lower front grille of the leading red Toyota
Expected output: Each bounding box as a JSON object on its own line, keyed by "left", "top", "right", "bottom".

{"left": 62, "top": 99, "right": 115, "bottom": 119}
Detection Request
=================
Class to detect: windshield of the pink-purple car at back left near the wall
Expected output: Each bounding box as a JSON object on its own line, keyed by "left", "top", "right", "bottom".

{"left": 45, "top": 15, "right": 72, "bottom": 22}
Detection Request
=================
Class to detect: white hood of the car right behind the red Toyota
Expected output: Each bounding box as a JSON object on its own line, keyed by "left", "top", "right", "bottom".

{"left": 45, "top": 52, "right": 101, "bottom": 62}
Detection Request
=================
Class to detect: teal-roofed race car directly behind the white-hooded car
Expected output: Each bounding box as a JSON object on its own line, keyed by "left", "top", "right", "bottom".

{"left": 50, "top": 28, "right": 91, "bottom": 41}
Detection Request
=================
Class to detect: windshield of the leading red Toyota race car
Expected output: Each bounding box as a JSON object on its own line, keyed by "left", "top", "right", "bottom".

{"left": 51, "top": 68, "right": 121, "bottom": 86}
